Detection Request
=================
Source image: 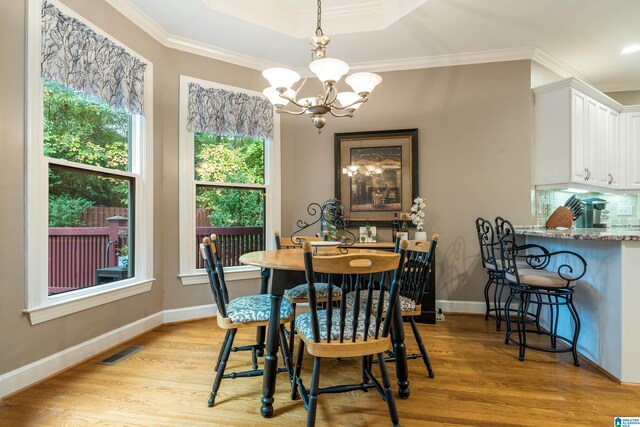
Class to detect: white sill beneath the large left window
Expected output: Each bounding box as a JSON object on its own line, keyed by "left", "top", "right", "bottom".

{"left": 24, "top": 279, "right": 155, "bottom": 325}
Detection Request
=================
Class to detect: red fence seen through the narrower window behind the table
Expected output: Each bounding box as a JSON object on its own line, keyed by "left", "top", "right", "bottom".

{"left": 196, "top": 227, "right": 264, "bottom": 268}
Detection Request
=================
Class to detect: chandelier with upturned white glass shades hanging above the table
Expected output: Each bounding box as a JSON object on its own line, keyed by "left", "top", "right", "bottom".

{"left": 262, "top": 0, "right": 382, "bottom": 133}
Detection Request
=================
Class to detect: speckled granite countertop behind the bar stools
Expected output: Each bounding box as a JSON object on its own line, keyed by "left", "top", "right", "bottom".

{"left": 514, "top": 225, "right": 640, "bottom": 241}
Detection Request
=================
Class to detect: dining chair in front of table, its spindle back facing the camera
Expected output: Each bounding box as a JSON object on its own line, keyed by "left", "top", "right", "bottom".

{"left": 292, "top": 242, "right": 406, "bottom": 427}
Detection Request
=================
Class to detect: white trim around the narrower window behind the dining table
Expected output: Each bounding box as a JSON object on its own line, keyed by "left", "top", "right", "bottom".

{"left": 178, "top": 75, "right": 280, "bottom": 286}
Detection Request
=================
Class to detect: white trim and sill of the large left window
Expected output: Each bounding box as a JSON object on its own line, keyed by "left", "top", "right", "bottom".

{"left": 24, "top": 0, "right": 155, "bottom": 325}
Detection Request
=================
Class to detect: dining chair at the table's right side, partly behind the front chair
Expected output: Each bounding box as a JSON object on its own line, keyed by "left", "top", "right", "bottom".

{"left": 347, "top": 234, "right": 440, "bottom": 378}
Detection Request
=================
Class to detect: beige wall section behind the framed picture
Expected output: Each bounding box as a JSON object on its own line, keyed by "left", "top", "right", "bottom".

{"left": 282, "top": 61, "right": 533, "bottom": 301}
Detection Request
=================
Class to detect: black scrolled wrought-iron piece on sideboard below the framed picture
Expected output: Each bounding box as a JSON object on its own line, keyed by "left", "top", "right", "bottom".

{"left": 291, "top": 199, "right": 357, "bottom": 245}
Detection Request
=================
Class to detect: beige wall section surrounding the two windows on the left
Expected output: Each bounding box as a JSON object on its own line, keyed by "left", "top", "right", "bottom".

{"left": 0, "top": 0, "right": 263, "bottom": 374}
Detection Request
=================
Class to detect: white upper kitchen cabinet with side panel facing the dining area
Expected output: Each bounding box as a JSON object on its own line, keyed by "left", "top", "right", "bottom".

{"left": 534, "top": 78, "right": 624, "bottom": 188}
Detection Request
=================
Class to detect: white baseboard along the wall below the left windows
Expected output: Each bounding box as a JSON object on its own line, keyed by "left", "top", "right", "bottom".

{"left": 0, "top": 304, "right": 217, "bottom": 398}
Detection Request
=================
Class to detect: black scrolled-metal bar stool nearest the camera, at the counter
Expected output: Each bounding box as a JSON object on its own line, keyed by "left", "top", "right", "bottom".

{"left": 496, "top": 217, "right": 587, "bottom": 366}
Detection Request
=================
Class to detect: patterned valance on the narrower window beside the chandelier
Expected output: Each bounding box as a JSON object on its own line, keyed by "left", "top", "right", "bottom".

{"left": 187, "top": 83, "right": 273, "bottom": 139}
